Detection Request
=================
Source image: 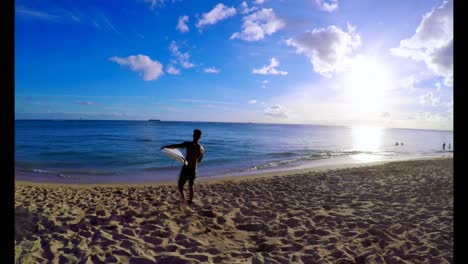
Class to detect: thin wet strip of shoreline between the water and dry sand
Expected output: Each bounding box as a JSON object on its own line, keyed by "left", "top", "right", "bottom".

{"left": 15, "top": 154, "right": 453, "bottom": 188}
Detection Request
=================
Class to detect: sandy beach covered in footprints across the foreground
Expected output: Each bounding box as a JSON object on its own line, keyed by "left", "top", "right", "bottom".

{"left": 15, "top": 159, "right": 453, "bottom": 263}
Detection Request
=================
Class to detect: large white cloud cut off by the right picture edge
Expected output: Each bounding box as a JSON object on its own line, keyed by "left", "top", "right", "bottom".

{"left": 390, "top": 1, "right": 453, "bottom": 86}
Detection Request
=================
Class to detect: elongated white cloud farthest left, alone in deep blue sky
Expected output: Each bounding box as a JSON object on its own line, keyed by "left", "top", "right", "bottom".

{"left": 109, "top": 54, "right": 164, "bottom": 81}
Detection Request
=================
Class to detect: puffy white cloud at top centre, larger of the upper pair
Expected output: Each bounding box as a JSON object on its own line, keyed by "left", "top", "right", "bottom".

{"left": 230, "top": 8, "right": 285, "bottom": 41}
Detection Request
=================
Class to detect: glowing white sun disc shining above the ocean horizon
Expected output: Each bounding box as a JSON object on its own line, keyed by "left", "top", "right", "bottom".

{"left": 342, "top": 55, "right": 394, "bottom": 113}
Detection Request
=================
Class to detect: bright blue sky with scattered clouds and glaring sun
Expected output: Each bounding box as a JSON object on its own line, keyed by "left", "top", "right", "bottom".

{"left": 15, "top": 0, "right": 453, "bottom": 130}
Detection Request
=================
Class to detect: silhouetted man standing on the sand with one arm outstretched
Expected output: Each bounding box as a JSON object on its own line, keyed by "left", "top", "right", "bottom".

{"left": 161, "top": 129, "right": 205, "bottom": 204}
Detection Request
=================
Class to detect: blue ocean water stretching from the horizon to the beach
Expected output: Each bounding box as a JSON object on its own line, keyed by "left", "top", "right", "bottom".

{"left": 15, "top": 120, "right": 454, "bottom": 183}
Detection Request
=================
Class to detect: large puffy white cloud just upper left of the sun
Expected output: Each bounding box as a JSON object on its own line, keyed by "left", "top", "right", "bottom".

{"left": 286, "top": 24, "right": 361, "bottom": 78}
